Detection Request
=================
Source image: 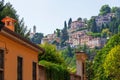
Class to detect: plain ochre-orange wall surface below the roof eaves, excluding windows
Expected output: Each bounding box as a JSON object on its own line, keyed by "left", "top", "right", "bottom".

{"left": 0, "top": 34, "right": 38, "bottom": 80}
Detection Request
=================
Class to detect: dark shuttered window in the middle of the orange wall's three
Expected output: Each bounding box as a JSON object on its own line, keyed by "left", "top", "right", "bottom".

{"left": 17, "top": 57, "right": 23, "bottom": 80}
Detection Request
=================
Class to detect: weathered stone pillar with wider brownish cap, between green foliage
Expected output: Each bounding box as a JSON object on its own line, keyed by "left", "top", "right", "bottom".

{"left": 76, "top": 52, "right": 87, "bottom": 80}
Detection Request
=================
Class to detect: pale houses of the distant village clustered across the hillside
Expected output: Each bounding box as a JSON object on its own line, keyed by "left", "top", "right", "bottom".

{"left": 35, "top": 13, "right": 115, "bottom": 48}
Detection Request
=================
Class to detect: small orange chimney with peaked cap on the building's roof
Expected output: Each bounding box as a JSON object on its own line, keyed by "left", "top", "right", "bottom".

{"left": 1, "top": 16, "right": 16, "bottom": 31}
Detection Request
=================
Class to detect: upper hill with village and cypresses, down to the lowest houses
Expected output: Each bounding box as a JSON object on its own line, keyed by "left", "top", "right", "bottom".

{"left": 37, "top": 5, "right": 120, "bottom": 49}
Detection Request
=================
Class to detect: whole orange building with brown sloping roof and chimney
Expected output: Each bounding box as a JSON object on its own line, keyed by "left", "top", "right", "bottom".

{"left": 0, "top": 17, "right": 44, "bottom": 80}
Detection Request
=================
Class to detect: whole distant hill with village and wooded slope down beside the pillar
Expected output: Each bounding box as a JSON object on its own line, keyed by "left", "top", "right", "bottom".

{"left": 32, "top": 5, "right": 120, "bottom": 72}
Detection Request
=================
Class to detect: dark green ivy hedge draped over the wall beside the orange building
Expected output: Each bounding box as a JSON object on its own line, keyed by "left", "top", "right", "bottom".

{"left": 39, "top": 60, "right": 70, "bottom": 80}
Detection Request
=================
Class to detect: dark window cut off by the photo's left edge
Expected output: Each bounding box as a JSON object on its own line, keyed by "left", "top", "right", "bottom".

{"left": 0, "top": 50, "right": 4, "bottom": 80}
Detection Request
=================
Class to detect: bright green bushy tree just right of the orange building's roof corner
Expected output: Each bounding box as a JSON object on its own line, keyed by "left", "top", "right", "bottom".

{"left": 39, "top": 43, "right": 64, "bottom": 64}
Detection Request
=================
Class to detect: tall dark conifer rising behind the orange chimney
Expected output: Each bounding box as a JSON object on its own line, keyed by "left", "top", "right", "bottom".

{"left": 0, "top": 3, "right": 30, "bottom": 39}
